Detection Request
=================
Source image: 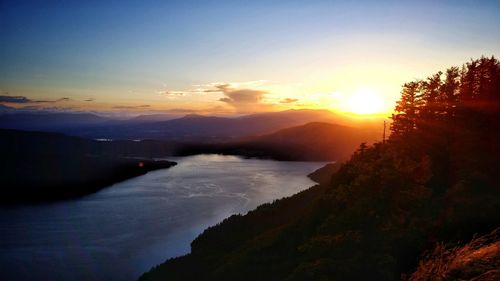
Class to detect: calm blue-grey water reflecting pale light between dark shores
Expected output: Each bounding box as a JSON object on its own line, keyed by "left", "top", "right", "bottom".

{"left": 0, "top": 155, "right": 324, "bottom": 280}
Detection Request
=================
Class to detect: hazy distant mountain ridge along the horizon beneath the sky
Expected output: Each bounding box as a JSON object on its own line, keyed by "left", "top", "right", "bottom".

{"left": 0, "top": 109, "right": 378, "bottom": 142}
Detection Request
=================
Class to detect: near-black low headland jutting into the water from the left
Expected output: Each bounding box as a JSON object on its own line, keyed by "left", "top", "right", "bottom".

{"left": 0, "top": 130, "right": 175, "bottom": 204}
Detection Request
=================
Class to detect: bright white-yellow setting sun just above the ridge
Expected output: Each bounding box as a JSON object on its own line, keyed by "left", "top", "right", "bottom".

{"left": 343, "top": 88, "right": 387, "bottom": 114}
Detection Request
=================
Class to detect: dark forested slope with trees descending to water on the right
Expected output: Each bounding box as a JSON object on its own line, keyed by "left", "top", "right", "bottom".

{"left": 141, "top": 58, "right": 500, "bottom": 280}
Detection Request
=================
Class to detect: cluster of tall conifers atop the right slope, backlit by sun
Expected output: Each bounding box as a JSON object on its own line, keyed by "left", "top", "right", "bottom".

{"left": 391, "top": 57, "right": 500, "bottom": 138}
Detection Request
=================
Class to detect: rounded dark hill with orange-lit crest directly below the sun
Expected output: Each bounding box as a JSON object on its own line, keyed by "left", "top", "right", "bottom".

{"left": 179, "top": 122, "right": 382, "bottom": 161}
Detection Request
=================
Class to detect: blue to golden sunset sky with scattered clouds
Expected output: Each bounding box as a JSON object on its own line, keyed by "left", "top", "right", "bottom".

{"left": 0, "top": 0, "right": 500, "bottom": 115}
